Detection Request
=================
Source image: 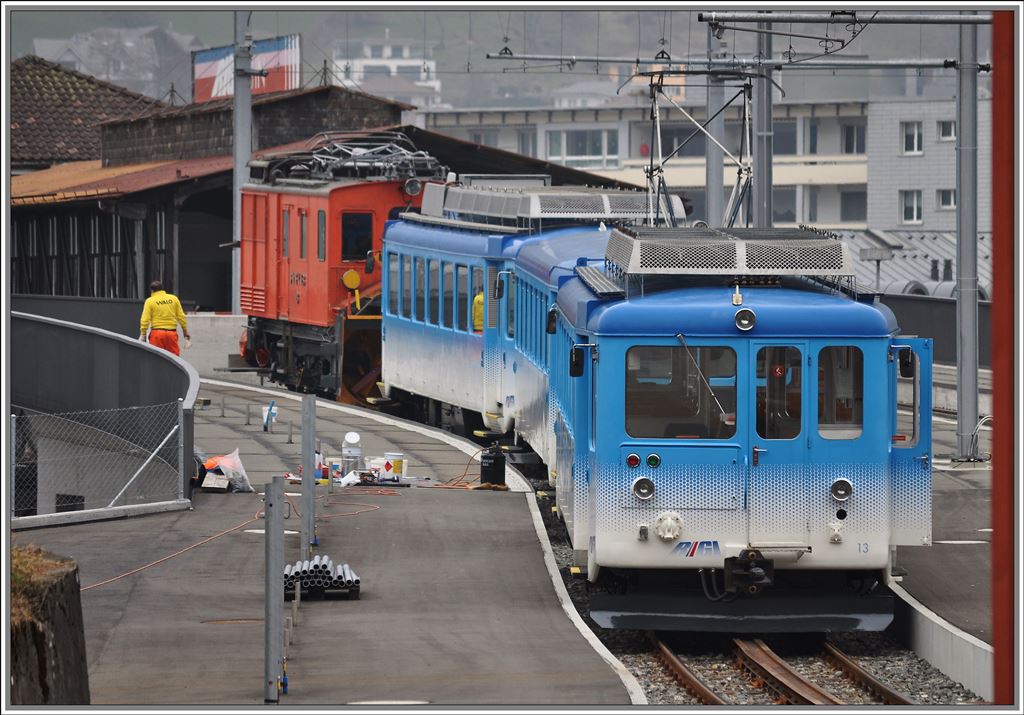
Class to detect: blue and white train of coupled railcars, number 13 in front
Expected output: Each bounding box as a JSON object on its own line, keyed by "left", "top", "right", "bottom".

{"left": 382, "top": 178, "right": 931, "bottom": 632}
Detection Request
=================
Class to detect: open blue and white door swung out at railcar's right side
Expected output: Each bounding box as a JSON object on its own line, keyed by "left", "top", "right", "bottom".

{"left": 889, "top": 337, "right": 932, "bottom": 546}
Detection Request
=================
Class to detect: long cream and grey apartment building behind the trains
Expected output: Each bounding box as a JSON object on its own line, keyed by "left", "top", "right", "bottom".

{"left": 419, "top": 72, "right": 991, "bottom": 232}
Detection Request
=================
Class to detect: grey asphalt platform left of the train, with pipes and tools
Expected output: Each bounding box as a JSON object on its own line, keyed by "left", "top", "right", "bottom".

{"left": 12, "top": 385, "right": 630, "bottom": 706}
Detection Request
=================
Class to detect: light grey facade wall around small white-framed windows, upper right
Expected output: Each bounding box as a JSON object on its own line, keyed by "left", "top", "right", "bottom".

{"left": 867, "top": 98, "right": 987, "bottom": 232}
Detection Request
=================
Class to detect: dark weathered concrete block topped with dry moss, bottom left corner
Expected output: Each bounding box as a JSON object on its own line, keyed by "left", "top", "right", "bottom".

{"left": 10, "top": 554, "right": 89, "bottom": 705}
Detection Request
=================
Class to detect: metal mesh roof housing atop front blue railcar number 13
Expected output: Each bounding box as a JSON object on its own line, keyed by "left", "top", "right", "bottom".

{"left": 605, "top": 227, "right": 854, "bottom": 277}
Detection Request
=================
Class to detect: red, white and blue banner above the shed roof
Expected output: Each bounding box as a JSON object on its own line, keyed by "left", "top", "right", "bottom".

{"left": 193, "top": 35, "right": 302, "bottom": 102}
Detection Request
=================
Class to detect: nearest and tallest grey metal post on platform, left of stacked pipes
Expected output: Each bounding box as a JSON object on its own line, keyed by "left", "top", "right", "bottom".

{"left": 263, "top": 476, "right": 285, "bottom": 703}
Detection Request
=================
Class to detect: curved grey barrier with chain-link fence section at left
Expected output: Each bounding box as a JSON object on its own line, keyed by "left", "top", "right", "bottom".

{"left": 12, "top": 312, "right": 199, "bottom": 529}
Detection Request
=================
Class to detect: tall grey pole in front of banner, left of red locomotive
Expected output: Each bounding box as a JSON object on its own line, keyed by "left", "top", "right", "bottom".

{"left": 231, "top": 10, "right": 252, "bottom": 316}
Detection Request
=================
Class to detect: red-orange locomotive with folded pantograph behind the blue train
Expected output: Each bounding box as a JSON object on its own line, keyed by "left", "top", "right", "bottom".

{"left": 240, "top": 133, "right": 447, "bottom": 403}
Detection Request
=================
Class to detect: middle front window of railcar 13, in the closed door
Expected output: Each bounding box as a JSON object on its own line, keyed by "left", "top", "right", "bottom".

{"left": 757, "top": 345, "right": 803, "bottom": 439}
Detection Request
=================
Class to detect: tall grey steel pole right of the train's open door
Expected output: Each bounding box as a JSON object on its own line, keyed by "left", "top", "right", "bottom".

{"left": 955, "top": 13, "right": 978, "bottom": 460}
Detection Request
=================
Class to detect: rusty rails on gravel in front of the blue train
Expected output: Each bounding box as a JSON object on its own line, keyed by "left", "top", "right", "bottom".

{"left": 654, "top": 638, "right": 914, "bottom": 706}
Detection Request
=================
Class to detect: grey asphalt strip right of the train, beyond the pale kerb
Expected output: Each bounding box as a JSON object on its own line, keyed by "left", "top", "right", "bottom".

{"left": 896, "top": 417, "right": 991, "bottom": 643}
